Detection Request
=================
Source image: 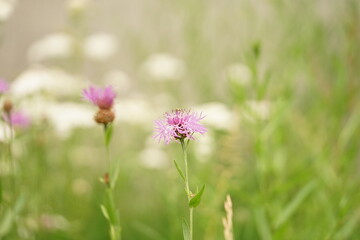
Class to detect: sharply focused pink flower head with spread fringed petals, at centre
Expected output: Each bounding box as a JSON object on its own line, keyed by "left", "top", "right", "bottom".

{"left": 154, "top": 109, "right": 207, "bottom": 144}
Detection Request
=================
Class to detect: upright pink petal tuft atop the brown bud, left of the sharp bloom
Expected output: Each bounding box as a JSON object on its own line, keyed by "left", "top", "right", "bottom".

{"left": 83, "top": 86, "right": 116, "bottom": 109}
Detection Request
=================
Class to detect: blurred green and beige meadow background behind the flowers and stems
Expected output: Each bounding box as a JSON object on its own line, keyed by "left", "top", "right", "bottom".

{"left": 0, "top": 0, "right": 360, "bottom": 240}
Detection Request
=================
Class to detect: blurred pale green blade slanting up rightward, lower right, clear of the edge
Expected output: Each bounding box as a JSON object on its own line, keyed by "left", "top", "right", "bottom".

{"left": 275, "top": 181, "right": 316, "bottom": 228}
